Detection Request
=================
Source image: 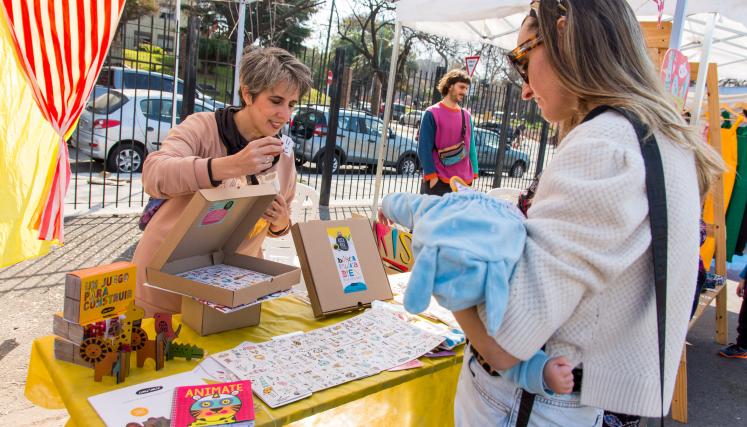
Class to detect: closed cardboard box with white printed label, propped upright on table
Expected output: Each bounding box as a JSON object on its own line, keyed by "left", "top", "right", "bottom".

{"left": 291, "top": 219, "right": 392, "bottom": 317}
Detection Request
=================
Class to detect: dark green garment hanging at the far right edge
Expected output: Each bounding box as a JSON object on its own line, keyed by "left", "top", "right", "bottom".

{"left": 726, "top": 126, "right": 747, "bottom": 262}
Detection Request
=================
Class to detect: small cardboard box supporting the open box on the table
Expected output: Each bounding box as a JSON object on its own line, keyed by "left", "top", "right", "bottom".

{"left": 182, "top": 297, "right": 262, "bottom": 336}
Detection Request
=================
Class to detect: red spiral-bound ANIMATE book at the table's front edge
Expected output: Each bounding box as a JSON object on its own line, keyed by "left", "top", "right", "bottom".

{"left": 171, "top": 380, "right": 254, "bottom": 427}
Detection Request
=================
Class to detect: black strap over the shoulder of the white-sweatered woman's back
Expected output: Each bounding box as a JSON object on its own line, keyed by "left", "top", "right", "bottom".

{"left": 582, "top": 105, "right": 668, "bottom": 425}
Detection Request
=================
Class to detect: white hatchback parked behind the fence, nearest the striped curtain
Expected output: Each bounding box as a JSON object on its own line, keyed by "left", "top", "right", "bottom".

{"left": 70, "top": 89, "right": 214, "bottom": 173}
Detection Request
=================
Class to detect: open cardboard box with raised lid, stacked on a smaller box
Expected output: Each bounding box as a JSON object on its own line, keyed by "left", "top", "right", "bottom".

{"left": 146, "top": 185, "right": 301, "bottom": 330}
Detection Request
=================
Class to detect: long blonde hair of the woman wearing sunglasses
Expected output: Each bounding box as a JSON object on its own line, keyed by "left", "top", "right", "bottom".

{"left": 526, "top": 0, "right": 724, "bottom": 197}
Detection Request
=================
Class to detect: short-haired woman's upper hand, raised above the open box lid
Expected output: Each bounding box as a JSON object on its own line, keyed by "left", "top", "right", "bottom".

{"left": 212, "top": 136, "right": 283, "bottom": 181}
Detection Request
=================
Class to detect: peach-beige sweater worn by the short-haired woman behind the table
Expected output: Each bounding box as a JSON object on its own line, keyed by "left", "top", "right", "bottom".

{"left": 132, "top": 113, "right": 296, "bottom": 316}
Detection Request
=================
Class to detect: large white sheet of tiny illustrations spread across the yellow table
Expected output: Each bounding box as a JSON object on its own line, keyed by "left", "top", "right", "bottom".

{"left": 212, "top": 310, "right": 443, "bottom": 408}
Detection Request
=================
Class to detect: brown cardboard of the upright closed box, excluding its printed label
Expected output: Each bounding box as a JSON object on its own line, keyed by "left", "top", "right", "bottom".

{"left": 292, "top": 219, "right": 392, "bottom": 316}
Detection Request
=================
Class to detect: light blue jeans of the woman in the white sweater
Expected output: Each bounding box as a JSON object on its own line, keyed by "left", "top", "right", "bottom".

{"left": 454, "top": 347, "right": 603, "bottom": 427}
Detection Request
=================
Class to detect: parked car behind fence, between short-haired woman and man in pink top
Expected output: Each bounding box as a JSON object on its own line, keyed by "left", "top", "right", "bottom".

{"left": 288, "top": 105, "right": 420, "bottom": 174}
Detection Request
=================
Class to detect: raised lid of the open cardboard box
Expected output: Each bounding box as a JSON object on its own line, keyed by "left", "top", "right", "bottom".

{"left": 148, "top": 184, "right": 276, "bottom": 270}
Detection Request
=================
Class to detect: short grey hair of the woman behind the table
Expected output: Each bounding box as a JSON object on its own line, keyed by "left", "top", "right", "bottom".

{"left": 239, "top": 46, "right": 312, "bottom": 107}
